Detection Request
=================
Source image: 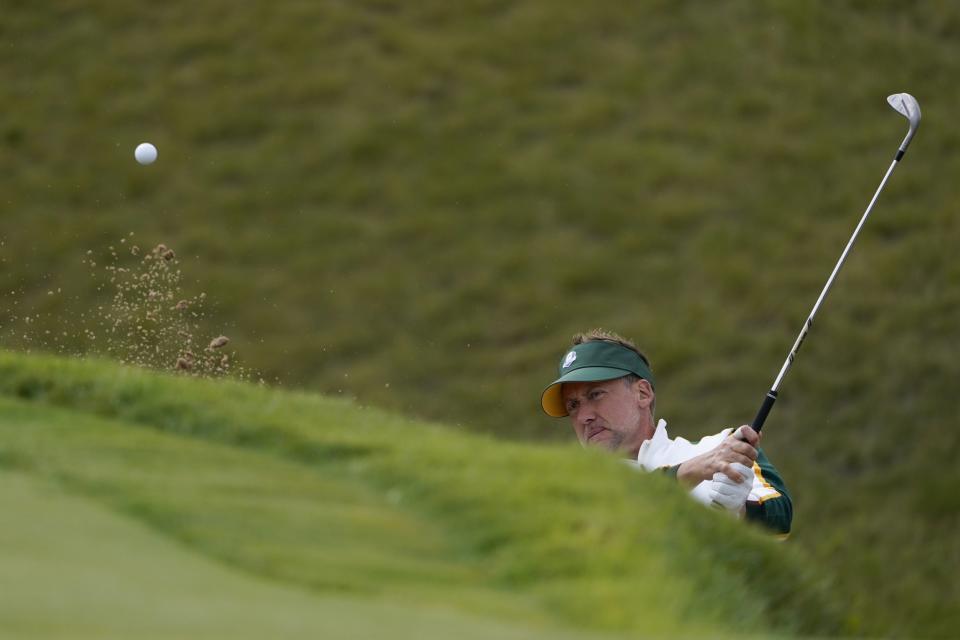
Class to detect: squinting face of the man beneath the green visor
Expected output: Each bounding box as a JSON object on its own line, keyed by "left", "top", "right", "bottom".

{"left": 561, "top": 378, "right": 654, "bottom": 457}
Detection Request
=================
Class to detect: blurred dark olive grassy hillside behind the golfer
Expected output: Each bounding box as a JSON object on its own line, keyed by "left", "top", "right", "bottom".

{"left": 0, "top": 0, "right": 960, "bottom": 636}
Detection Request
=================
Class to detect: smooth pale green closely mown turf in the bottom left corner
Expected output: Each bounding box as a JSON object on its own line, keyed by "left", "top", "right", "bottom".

{"left": 0, "top": 470, "right": 589, "bottom": 640}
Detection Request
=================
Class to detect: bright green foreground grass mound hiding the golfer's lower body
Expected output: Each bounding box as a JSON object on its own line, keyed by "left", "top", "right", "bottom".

{"left": 0, "top": 353, "right": 844, "bottom": 637}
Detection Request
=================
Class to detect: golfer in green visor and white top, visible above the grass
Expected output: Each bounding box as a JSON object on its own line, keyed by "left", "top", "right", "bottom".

{"left": 541, "top": 329, "right": 793, "bottom": 538}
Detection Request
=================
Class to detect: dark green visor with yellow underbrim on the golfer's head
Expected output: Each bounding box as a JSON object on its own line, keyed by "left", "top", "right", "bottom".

{"left": 540, "top": 340, "right": 654, "bottom": 418}
